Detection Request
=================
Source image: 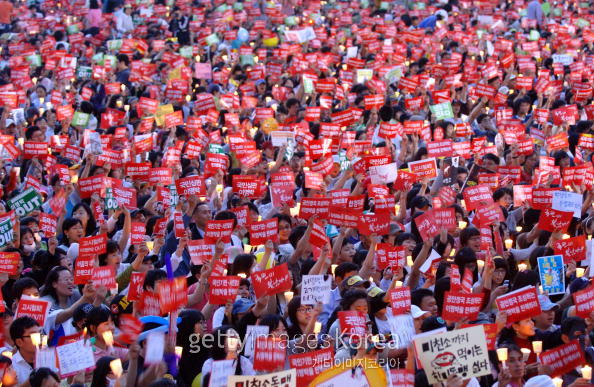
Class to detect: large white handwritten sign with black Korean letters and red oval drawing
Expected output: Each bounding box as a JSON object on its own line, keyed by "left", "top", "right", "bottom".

{"left": 414, "top": 326, "right": 491, "bottom": 384}
